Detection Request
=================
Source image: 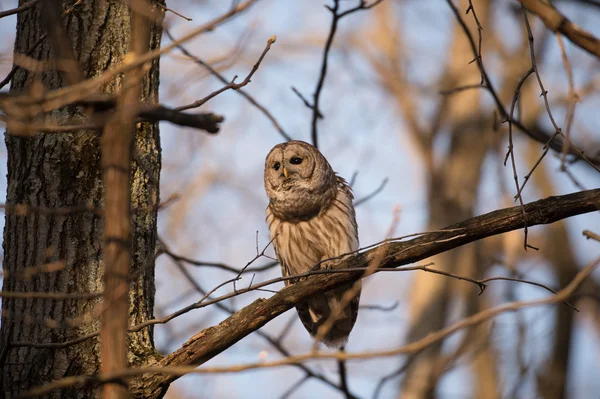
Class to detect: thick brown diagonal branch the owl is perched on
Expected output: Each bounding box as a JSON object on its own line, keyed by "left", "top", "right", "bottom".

{"left": 127, "top": 189, "right": 600, "bottom": 397}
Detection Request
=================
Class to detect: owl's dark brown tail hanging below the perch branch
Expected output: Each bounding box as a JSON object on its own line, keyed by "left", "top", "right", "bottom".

{"left": 296, "top": 284, "right": 360, "bottom": 349}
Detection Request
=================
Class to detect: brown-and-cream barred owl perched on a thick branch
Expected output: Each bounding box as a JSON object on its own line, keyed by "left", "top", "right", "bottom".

{"left": 264, "top": 141, "right": 360, "bottom": 348}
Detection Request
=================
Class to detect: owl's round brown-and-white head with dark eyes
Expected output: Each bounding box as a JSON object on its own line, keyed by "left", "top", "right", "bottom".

{"left": 265, "top": 141, "right": 336, "bottom": 218}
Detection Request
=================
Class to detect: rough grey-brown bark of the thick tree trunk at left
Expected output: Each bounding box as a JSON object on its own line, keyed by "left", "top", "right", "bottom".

{"left": 0, "top": 0, "right": 161, "bottom": 398}
